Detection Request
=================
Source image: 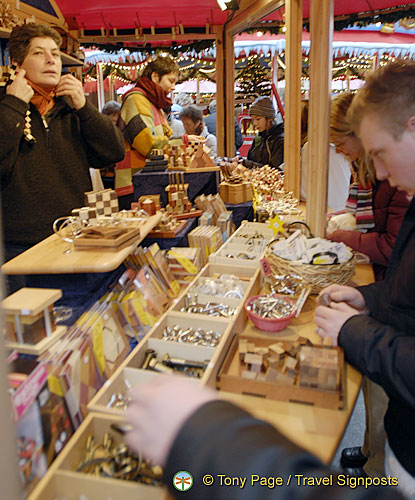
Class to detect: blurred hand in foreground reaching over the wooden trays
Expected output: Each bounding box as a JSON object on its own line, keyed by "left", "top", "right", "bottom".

{"left": 125, "top": 375, "right": 218, "bottom": 467}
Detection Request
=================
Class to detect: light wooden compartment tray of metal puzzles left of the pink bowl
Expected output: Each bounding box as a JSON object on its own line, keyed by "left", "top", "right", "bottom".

{"left": 88, "top": 264, "right": 261, "bottom": 415}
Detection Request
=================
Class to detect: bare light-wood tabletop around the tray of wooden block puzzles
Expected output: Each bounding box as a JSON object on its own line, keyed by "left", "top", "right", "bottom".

{"left": 220, "top": 264, "right": 374, "bottom": 464}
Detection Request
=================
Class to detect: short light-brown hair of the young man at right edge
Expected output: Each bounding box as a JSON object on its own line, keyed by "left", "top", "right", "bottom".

{"left": 347, "top": 59, "right": 415, "bottom": 139}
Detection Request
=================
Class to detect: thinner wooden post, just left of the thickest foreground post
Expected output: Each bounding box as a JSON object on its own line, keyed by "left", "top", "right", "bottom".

{"left": 284, "top": 0, "right": 303, "bottom": 198}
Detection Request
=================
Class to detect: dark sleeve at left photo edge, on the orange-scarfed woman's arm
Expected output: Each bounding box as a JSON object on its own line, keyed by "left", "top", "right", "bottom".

{"left": 0, "top": 95, "right": 29, "bottom": 184}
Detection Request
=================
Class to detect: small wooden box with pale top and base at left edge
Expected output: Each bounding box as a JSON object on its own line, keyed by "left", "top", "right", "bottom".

{"left": 1, "top": 288, "right": 66, "bottom": 354}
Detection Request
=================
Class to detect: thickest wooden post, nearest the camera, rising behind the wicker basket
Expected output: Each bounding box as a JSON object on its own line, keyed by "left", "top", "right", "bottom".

{"left": 307, "top": 0, "right": 334, "bottom": 237}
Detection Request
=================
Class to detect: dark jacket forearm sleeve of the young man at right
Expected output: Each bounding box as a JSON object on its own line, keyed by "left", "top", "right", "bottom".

{"left": 339, "top": 315, "right": 415, "bottom": 408}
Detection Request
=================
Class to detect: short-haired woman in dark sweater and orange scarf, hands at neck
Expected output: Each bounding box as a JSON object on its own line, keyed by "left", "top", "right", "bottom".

{"left": 0, "top": 23, "right": 124, "bottom": 270}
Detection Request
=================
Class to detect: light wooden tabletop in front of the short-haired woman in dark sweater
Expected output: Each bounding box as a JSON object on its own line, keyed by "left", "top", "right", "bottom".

{"left": 1, "top": 213, "right": 161, "bottom": 274}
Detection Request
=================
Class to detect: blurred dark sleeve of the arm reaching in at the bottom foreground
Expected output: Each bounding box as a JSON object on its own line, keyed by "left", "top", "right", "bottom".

{"left": 164, "top": 401, "right": 401, "bottom": 500}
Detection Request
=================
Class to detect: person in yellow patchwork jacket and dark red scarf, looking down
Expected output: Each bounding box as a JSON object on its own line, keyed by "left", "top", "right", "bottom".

{"left": 115, "top": 57, "right": 179, "bottom": 208}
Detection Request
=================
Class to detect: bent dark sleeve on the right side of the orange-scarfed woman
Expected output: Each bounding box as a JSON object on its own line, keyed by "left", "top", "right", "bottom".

{"left": 77, "top": 101, "right": 125, "bottom": 168}
